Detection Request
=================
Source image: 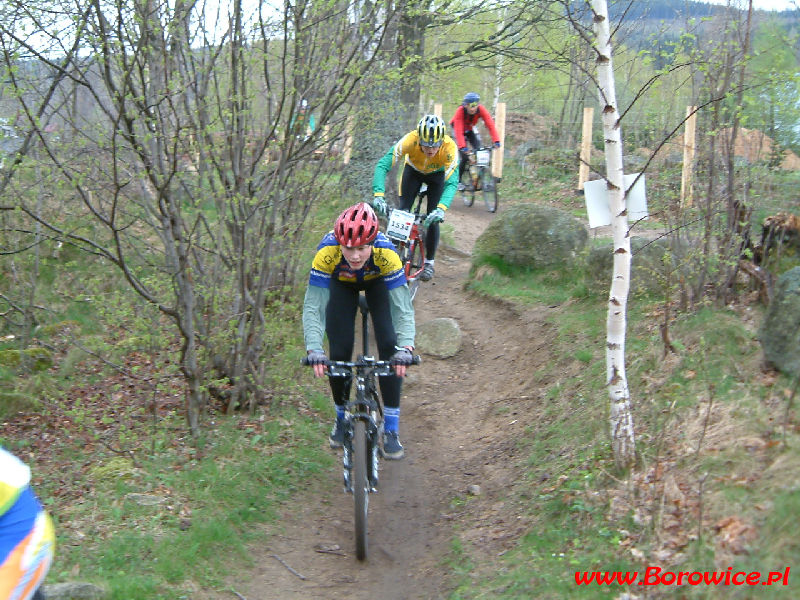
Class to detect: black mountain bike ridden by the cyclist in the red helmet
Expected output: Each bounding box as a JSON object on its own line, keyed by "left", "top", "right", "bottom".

{"left": 302, "top": 294, "right": 420, "bottom": 560}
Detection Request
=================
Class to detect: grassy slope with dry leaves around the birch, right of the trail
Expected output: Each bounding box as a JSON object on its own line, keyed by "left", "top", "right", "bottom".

{"left": 450, "top": 246, "right": 800, "bottom": 600}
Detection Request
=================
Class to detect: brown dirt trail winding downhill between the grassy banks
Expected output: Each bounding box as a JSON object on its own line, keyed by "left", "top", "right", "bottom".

{"left": 204, "top": 197, "right": 549, "bottom": 600}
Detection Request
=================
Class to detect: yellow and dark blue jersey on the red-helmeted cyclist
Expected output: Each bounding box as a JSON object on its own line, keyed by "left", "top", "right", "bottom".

{"left": 308, "top": 232, "right": 406, "bottom": 290}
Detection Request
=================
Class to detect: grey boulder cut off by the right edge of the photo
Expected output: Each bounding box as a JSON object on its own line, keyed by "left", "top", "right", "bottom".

{"left": 758, "top": 267, "right": 800, "bottom": 376}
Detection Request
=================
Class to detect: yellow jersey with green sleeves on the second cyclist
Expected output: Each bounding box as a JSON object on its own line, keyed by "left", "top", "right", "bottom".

{"left": 372, "top": 129, "right": 459, "bottom": 210}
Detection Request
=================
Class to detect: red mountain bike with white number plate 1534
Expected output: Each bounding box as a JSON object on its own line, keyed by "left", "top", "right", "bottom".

{"left": 386, "top": 183, "right": 428, "bottom": 302}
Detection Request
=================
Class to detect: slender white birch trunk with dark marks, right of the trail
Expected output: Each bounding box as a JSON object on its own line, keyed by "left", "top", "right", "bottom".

{"left": 592, "top": 0, "right": 636, "bottom": 469}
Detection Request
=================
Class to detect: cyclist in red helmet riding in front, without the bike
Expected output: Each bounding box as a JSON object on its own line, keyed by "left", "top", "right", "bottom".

{"left": 303, "top": 202, "right": 415, "bottom": 459}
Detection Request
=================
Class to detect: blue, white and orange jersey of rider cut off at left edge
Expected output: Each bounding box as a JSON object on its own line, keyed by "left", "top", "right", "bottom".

{"left": 0, "top": 448, "right": 55, "bottom": 600}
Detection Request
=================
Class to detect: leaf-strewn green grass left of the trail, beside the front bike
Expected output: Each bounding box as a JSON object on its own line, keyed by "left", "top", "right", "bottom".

{"left": 39, "top": 405, "right": 334, "bottom": 600}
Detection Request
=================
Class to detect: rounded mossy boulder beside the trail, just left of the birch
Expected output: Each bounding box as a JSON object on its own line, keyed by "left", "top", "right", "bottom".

{"left": 474, "top": 204, "right": 589, "bottom": 268}
